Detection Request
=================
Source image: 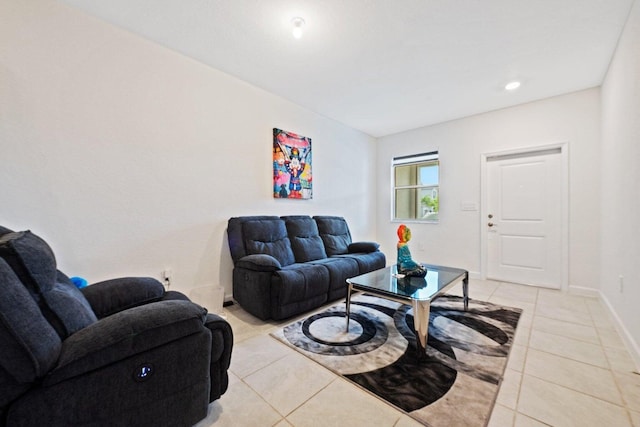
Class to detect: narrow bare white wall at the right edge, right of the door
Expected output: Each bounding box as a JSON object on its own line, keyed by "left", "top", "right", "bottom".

{"left": 600, "top": 1, "right": 640, "bottom": 366}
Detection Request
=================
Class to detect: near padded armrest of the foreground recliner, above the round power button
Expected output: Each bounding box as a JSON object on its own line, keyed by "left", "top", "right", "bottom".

{"left": 44, "top": 301, "right": 207, "bottom": 385}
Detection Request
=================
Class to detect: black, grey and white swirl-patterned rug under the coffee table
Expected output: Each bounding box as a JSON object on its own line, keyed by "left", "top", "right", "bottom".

{"left": 272, "top": 295, "right": 522, "bottom": 427}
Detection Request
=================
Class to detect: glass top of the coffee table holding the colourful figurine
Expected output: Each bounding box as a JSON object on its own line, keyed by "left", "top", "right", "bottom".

{"left": 347, "top": 264, "right": 467, "bottom": 301}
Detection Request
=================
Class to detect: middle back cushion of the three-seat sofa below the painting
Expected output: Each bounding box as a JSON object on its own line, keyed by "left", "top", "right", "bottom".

{"left": 282, "top": 216, "right": 327, "bottom": 262}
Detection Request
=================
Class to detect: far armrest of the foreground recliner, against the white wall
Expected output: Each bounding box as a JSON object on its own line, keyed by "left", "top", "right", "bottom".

{"left": 80, "top": 277, "right": 164, "bottom": 319}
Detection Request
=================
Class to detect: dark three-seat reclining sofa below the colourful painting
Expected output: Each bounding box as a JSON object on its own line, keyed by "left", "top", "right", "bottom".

{"left": 227, "top": 215, "right": 386, "bottom": 320}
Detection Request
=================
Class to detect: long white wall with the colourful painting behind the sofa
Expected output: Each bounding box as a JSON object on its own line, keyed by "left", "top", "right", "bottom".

{"left": 0, "top": 0, "right": 376, "bottom": 296}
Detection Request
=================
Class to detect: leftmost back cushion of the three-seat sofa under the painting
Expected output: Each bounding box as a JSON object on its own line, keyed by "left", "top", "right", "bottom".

{"left": 242, "top": 218, "right": 296, "bottom": 267}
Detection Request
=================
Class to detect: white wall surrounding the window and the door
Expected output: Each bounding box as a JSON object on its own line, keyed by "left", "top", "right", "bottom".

{"left": 377, "top": 88, "right": 600, "bottom": 290}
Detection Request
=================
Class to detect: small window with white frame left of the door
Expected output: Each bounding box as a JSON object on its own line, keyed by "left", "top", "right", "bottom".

{"left": 392, "top": 151, "right": 440, "bottom": 221}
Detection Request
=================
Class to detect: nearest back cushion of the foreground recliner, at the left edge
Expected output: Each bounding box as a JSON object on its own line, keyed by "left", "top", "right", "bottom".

{"left": 0, "top": 259, "right": 62, "bottom": 386}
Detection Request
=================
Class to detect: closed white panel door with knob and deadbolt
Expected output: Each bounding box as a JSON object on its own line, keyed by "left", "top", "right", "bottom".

{"left": 484, "top": 148, "right": 564, "bottom": 289}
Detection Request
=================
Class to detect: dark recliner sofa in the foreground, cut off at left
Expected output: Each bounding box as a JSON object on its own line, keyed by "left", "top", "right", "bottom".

{"left": 0, "top": 227, "right": 233, "bottom": 427}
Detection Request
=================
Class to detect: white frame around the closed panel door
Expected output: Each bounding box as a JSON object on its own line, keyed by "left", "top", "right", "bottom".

{"left": 480, "top": 142, "right": 569, "bottom": 291}
